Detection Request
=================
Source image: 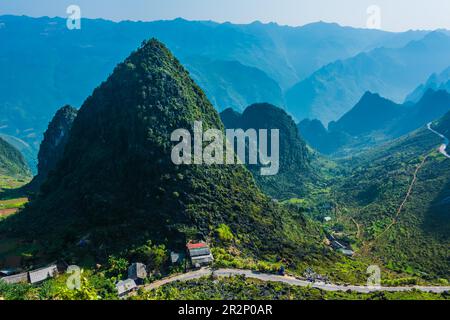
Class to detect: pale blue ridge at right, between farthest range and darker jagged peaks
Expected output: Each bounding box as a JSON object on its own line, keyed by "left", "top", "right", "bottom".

{"left": 286, "top": 32, "right": 450, "bottom": 123}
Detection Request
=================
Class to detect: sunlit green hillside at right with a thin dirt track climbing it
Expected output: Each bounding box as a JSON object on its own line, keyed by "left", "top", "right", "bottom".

{"left": 337, "top": 128, "right": 450, "bottom": 279}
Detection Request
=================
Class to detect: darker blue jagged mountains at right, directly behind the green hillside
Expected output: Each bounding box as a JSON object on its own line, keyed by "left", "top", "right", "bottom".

{"left": 298, "top": 89, "right": 450, "bottom": 156}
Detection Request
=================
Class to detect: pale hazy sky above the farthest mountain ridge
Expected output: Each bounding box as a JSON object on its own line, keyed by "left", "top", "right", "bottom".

{"left": 0, "top": 0, "right": 450, "bottom": 31}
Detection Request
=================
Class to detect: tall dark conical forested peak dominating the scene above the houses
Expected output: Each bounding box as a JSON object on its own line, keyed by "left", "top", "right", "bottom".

{"left": 5, "top": 40, "right": 324, "bottom": 262}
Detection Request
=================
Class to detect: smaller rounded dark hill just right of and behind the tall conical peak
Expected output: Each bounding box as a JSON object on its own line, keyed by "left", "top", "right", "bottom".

{"left": 220, "top": 103, "right": 314, "bottom": 199}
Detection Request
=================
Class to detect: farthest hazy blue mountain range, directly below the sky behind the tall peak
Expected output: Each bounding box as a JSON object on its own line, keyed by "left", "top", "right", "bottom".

{"left": 0, "top": 16, "right": 426, "bottom": 169}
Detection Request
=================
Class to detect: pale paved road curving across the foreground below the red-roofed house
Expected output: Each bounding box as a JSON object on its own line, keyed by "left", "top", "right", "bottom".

{"left": 144, "top": 268, "right": 450, "bottom": 293}
